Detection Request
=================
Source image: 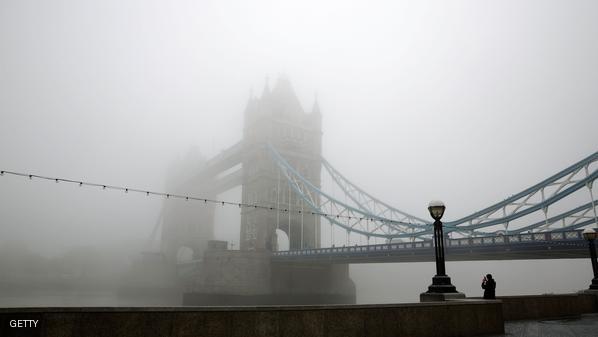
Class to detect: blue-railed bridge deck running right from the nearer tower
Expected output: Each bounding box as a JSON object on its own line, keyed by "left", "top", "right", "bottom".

{"left": 272, "top": 230, "right": 589, "bottom": 263}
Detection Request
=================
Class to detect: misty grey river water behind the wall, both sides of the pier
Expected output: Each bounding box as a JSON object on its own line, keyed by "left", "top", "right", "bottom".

{"left": 0, "top": 259, "right": 592, "bottom": 307}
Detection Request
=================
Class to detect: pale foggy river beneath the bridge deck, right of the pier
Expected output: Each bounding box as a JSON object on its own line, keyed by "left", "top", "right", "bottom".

{"left": 351, "top": 258, "right": 592, "bottom": 303}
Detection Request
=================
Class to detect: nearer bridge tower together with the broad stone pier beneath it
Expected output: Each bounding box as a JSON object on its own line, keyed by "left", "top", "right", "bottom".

{"left": 177, "top": 78, "right": 355, "bottom": 305}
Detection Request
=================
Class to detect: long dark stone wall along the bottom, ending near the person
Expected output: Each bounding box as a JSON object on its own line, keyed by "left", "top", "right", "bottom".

{"left": 0, "top": 301, "right": 504, "bottom": 337}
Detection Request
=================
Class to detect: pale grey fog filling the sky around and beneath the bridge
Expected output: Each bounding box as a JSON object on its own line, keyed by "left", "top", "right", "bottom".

{"left": 0, "top": 0, "right": 598, "bottom": 305}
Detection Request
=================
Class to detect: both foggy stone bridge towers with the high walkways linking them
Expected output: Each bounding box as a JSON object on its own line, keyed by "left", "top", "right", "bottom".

{"left": 159, "top": 78, "right": 322, "bottom": 260}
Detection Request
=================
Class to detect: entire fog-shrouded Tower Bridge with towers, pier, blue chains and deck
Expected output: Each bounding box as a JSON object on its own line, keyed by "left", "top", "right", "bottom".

{"left": 162, "top": 78, "right": 598, "bottom": 305}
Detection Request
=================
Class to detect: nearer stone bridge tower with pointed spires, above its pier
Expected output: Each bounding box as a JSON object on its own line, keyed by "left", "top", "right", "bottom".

{"left": 240, "top": 77, "right": 322, "bottom": 250}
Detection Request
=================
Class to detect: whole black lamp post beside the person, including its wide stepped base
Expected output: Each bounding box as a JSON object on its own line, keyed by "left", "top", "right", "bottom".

{"left": 420, "top": 200, "right": 465, "bottom": 302}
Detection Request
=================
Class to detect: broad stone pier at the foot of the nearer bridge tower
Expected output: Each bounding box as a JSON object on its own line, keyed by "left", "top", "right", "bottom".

{"left": 183, "top": 242, "right": 355, "bottom": 306}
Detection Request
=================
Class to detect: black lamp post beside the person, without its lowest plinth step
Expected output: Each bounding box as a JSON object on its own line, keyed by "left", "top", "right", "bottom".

{"left": 427, "top": 200, "right": 457, "bottom": 293}
